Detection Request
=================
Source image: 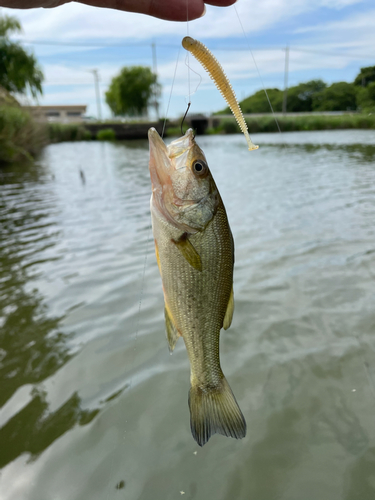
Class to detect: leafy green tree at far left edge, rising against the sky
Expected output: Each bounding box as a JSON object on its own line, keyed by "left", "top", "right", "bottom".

{"left": 0, "top": 16, "right": 44, "bottom": 97}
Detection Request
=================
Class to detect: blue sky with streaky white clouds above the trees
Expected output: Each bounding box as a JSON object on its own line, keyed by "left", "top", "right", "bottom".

{"left": 1, "top": 0, "right": 375, "bottom": 118}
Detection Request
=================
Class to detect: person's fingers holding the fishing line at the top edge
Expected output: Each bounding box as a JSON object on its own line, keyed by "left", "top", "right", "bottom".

{"left": 0, "top": 0, "right": 237, "bottom": 21}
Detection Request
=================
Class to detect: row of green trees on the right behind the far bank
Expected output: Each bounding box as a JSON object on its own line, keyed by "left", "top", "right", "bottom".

{"left": 217, "top": 66, "right": 375, "bottom": 114}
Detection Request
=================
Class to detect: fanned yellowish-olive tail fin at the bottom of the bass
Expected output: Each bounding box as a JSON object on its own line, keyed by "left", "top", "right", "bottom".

{"left": 189, "top": 377, "right": 246, "bottom": 446}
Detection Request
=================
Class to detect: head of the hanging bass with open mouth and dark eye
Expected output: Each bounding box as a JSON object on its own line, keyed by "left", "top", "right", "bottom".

{"left": 148, "top": 128, "right": 220, "bottom": 233}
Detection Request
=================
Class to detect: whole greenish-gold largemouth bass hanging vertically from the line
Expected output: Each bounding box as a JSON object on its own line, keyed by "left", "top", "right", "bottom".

{"left": 148, "top": 128, "right": 246, "bottom": 446}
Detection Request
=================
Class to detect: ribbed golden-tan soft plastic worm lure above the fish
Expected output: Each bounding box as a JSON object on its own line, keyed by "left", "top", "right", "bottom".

{"left": 182, "top": 36, "right": 259, "bottom": 151}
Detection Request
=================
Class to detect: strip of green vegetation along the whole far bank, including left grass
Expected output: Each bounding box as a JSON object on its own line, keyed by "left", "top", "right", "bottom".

{"left": 0, "top": 110, "right": 375, "bottom": 164}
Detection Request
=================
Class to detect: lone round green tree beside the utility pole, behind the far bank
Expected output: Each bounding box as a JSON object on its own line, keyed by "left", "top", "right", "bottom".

{"left": 105, "top": 66, "right": 160, "bottom": 116}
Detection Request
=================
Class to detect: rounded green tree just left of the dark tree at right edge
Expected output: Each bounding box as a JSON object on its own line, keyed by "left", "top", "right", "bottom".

{"left": 313, "top": 82, "right": 357, "bottom": 111}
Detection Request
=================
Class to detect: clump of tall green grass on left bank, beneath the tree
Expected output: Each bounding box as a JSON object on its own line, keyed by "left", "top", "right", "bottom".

{"left": 0, "top": 105, "right": 48, "bottom": 164}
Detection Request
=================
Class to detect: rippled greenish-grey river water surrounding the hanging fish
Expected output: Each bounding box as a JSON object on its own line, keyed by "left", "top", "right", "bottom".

{"left": 0, "top": 131, "right": 375, "bottom": 500}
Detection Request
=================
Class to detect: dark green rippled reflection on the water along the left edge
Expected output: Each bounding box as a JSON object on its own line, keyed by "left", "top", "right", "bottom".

{"left": 0, "top": 163, "right": 84, "bottom": 467}
